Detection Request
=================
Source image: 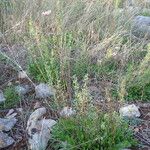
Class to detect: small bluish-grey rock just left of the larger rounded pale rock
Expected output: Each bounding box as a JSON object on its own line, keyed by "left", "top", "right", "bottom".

{"left": 15, "top": 85, "right": 30, "bottom": 95}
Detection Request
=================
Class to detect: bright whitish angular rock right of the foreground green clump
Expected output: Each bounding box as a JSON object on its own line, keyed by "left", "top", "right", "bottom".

{"left": 119, "top": 104, "right": 141, "bottom": 117}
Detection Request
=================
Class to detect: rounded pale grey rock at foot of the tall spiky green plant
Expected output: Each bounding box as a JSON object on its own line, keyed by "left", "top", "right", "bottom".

{"left": 35, "top": 83, "right": 55, "bottom": 98}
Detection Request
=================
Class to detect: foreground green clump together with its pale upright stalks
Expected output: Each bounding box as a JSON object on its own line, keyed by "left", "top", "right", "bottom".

{"left": 49, "top": 76, "right": 137, "bottom": 150}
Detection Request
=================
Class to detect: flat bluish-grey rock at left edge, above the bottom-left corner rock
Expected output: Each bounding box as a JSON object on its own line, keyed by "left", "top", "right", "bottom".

{"left": 0, "top": 118, "right": 17, "bottom": 131}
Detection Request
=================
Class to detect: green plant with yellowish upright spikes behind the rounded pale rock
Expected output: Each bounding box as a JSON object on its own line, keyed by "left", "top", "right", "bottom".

{"left": 28, "top": 37, "right": 60, "bottom": 85}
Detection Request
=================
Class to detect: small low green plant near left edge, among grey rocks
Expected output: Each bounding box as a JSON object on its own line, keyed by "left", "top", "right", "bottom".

{"left": 0, "top": 86, "right": 21, "bottom": 109}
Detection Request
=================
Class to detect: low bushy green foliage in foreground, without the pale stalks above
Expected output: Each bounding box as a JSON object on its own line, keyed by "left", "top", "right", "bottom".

{"left": 51, "top": 113, "right": 136, "bottom": 150}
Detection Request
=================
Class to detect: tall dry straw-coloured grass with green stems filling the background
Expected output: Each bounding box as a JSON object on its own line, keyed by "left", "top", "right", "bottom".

{"left": 0, "top": 0, "right": 149, "bottom": 102}
